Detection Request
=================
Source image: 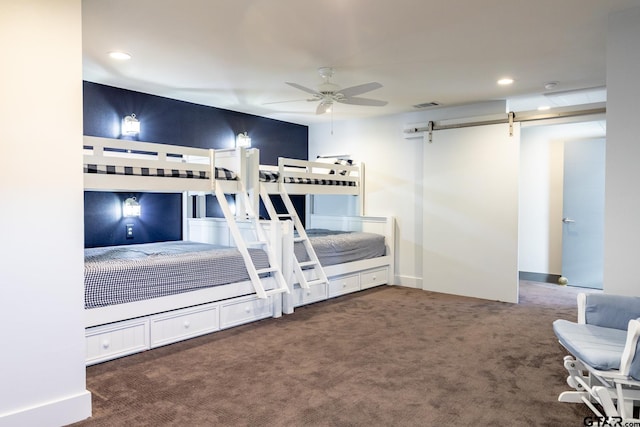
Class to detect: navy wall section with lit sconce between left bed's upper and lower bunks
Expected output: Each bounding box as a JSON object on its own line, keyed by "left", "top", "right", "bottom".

{"left": 84, "top": 191, "right": 182, "bottom": 248}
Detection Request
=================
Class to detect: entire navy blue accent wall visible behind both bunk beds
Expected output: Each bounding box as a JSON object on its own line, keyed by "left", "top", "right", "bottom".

{"left": 83, "top": 81, "right": 309, "bottom": 247}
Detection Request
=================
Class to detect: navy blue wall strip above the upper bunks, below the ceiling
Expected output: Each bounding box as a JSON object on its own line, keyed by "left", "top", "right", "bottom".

{"left": 83, "top": 82, "right": 309, "bottom": 159}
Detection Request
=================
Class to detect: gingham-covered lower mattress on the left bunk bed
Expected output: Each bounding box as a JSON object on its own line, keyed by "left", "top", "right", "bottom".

{"left": 84, "top": 241, "right": 269, "bottom": 309}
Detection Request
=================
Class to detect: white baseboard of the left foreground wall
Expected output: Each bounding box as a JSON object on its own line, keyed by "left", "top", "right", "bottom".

{"left": 0, "top": 390, "right": 91, "bottom": 427}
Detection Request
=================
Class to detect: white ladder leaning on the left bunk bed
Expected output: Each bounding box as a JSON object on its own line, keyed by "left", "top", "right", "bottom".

{"left": 215, "top": 185, "right": 290, "bottom": 298}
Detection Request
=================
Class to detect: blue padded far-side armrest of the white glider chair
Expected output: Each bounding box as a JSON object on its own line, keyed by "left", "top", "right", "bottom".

{"left": 578, "top": 293, "right": 640, "bottom": 331}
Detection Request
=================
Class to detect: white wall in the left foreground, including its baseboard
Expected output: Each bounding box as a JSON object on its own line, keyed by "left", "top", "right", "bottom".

{"left": 0, "top": 0, "right": 91, "bottom": 426}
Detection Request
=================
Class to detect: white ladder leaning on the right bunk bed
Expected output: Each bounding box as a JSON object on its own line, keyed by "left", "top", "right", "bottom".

{"left": 260, "top": 183, "right": 329, "bottom": 289}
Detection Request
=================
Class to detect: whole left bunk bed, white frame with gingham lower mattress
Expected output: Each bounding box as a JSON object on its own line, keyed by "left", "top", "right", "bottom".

{"left": 84, "top": 136, "right": 288, "bottom": 365}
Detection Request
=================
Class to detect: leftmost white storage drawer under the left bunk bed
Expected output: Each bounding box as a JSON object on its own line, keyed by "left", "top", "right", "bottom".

{"left": 85, "top": 319, "right": 149, "bottom": 365}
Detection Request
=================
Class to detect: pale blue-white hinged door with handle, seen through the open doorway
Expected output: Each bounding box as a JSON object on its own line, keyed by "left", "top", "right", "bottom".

{"left": 562, "top": 138, "right": 605, "bottom": 289}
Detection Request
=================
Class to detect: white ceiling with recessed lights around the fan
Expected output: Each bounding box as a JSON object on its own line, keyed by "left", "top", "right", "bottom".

{"left": 82, "top": 0, "right": 638, "bottom": 124}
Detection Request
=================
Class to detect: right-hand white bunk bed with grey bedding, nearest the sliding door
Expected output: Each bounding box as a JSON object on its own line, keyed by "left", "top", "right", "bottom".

{"left": 255, "top": 156, "right": 395, "bottom": 314}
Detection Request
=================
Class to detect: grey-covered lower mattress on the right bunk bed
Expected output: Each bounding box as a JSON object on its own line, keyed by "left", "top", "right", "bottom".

{"left": 294, "top": 228, "right": 386, "bottom": 267}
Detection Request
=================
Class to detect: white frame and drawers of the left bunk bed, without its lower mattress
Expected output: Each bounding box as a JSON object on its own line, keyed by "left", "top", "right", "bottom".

{"left": 84, "top": 136, "right": 288, "bottom": 365}
